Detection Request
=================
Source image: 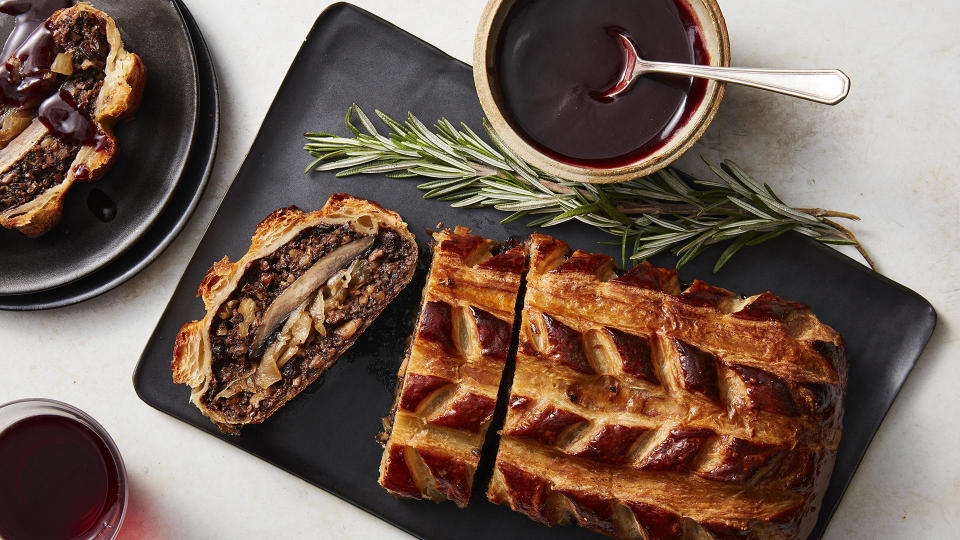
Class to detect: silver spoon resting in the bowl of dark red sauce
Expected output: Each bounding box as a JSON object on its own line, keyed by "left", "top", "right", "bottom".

{"left": 601, "top": 33, "right": 850, "bottom": 105}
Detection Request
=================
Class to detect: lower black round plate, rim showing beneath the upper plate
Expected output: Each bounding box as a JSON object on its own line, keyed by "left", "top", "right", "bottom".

{"left": 0, "top": 0, "right": 220, "bottom": 311}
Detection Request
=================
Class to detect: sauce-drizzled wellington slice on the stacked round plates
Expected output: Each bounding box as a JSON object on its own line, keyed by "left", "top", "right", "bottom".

{"left": 0, "top": 3, "right": 146, "bottom": 236}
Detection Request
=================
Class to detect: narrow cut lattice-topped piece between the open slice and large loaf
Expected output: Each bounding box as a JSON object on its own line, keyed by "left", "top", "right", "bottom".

{"left": 379, "top": 227, "right": 525, "bottom": 506}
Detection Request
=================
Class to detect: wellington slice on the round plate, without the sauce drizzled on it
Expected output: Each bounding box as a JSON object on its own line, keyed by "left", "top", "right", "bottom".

{"left": 0, "top": 3, "right": 146, "bottom": 236}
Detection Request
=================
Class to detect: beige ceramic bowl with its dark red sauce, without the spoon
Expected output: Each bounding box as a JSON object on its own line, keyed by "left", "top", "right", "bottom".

{"left": 473, "top": 0, "right": 730, "bottom": 183}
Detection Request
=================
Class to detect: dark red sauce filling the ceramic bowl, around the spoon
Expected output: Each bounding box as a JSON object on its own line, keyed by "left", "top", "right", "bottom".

{"left": 494, "top": 0, "right": 709, "bottom": 168}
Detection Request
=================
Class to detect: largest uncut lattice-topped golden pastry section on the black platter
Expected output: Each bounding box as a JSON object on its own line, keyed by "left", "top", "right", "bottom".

{"left": 488, "top": 235, "right": 847, "bottom": 540}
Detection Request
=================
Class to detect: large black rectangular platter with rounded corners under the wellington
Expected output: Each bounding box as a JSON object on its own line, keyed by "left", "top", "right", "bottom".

{"left": 134, "top": 4, "right": 936, "bottom": 539}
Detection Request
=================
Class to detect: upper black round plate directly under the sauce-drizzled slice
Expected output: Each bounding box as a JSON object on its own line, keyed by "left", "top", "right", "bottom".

{"left": 0, "top": 0, "right": 198, "bottom": 295}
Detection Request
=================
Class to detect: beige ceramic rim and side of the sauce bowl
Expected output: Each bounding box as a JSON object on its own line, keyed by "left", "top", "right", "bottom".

{"left": 473, "top": 0, "right": 730, "bottom": 184}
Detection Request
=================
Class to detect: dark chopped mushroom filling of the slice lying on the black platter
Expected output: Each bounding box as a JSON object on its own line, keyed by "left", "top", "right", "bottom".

{"left": 203, "top": 224, "right": 415, "bottom": 417}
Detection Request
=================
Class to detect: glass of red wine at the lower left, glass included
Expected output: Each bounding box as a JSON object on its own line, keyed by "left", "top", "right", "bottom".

{"left": 0, "top": 399, "right": 127, "bottom": 540}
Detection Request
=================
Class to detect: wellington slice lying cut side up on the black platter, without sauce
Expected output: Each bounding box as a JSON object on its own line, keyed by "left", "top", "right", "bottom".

{"left": 172, "top": 194, "right": 417, "bottom": 434}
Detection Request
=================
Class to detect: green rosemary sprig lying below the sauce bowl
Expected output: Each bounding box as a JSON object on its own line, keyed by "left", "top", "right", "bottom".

{"left": 304, "top": 104, "right": 874, "bottom": 271}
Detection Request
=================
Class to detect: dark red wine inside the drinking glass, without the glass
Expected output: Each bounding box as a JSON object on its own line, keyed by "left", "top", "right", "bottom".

{"left": 0, "top": 415, "right": 120, "bottom": 540}
